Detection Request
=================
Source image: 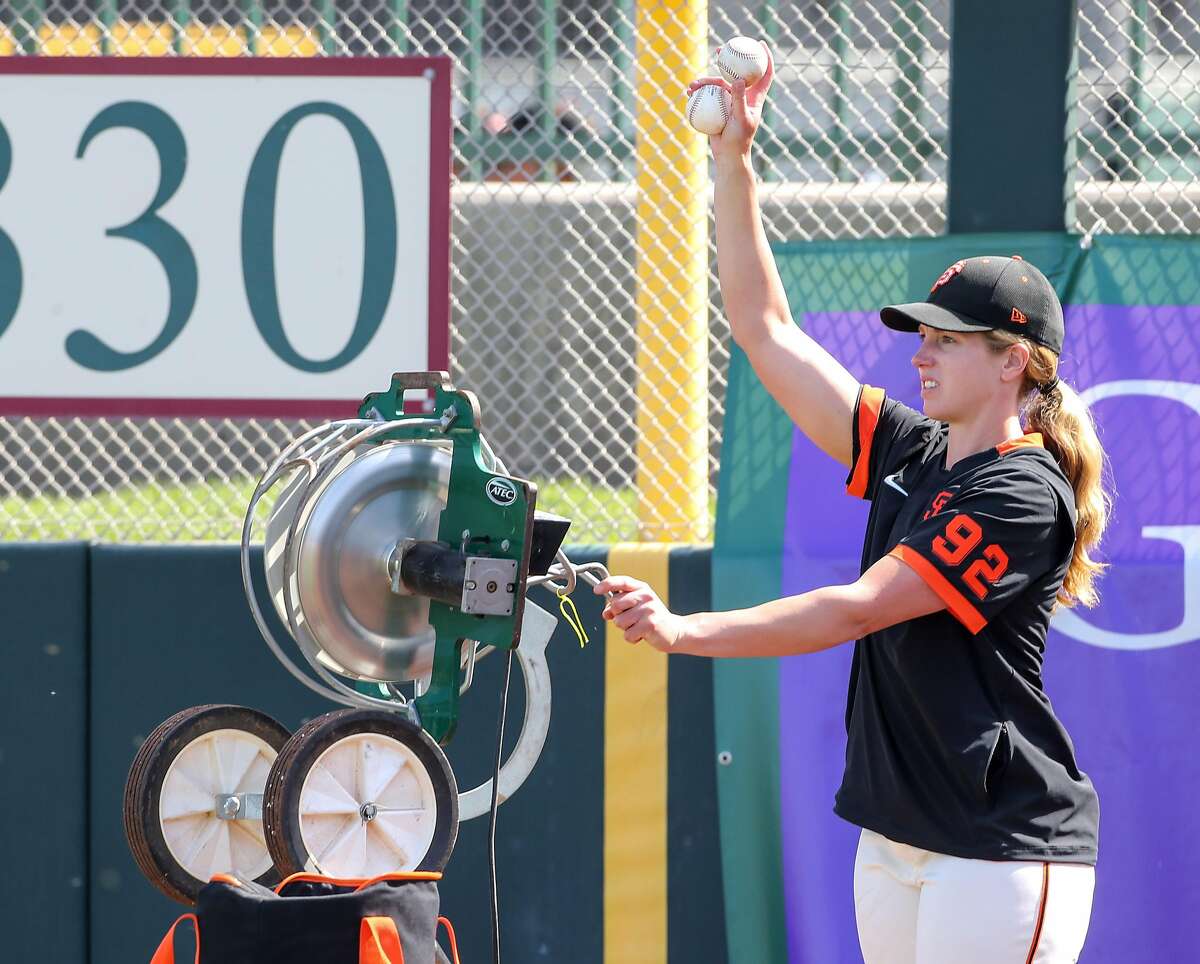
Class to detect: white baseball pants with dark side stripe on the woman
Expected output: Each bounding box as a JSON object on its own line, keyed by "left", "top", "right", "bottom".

{"left": 854, "top": 830, "right": 1096, "bottom": 964}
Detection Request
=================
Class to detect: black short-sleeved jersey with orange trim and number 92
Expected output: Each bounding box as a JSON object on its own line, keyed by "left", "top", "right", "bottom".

{"left": 834, "top": 385, "right": 1099, "bottom": 863}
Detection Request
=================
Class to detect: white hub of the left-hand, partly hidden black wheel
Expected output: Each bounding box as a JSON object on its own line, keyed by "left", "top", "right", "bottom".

{"left": 158, "top": 730, "right": 277, "bottom": 881}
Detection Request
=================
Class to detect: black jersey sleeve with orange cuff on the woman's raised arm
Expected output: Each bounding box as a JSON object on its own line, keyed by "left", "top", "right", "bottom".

{"left": 846, "top": 385, "right": 937, "bottom": 501}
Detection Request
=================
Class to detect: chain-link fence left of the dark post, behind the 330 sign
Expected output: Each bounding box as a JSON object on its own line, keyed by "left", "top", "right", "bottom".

{"left": 0, "top": 0, "right": 949, "bottom": 543}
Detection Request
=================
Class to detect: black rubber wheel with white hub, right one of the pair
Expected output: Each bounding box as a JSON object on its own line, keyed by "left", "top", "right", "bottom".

{"left": 263, "top": 709, "right": 458, "bottom": 879}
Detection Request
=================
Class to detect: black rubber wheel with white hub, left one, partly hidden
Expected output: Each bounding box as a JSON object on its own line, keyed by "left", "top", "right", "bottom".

{"left": 124, "top": 703, "right": 289, "bottom": 904}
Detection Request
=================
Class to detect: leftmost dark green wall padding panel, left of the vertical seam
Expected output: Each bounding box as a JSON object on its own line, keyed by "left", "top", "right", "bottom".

{"left": 0, "top": 543, "right": 89, "bottom": 964}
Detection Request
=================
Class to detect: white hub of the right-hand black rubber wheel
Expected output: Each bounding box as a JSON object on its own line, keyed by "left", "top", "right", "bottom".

{"left": 299, "top": 734, "right": 438, "bottom": 878}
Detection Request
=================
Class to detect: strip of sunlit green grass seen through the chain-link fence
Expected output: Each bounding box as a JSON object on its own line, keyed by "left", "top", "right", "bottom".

{"left": 0, "top": 478, "right": 715, "bottom": 545}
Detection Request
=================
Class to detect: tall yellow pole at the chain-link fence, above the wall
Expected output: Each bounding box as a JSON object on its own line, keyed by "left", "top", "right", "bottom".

{"left": 637, "top": 0, "right": 709, "bottom": 543}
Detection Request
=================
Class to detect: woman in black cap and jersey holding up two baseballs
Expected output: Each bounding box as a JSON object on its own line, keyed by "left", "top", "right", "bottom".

{"left": 596, "top": 47, "right": 1110, "bottom": 964}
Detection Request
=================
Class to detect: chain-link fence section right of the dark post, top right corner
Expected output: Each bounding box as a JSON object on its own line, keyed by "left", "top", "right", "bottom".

{"left": 1068, "top": 0, "right": 1200, "bottom": 234}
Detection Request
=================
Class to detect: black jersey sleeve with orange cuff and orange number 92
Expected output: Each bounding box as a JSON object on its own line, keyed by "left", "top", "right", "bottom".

{"left": 889, "top": 457, "right": 1063, "bottom": 634}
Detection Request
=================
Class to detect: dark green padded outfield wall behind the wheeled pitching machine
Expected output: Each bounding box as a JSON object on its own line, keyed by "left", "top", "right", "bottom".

{"left": 0, "top": 543, "right": 725, "bottom": 964}
